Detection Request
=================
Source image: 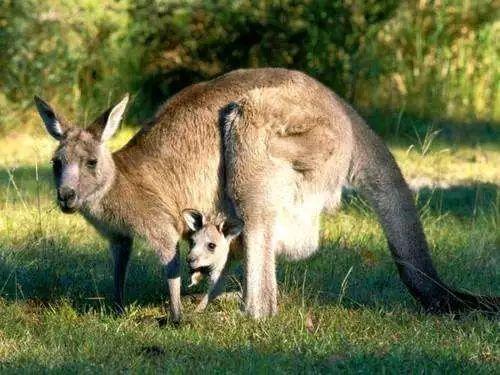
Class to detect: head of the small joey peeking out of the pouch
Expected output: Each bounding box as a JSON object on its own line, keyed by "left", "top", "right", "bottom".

{"left": 182, "top": 209, "right": 241, "bottom": 270}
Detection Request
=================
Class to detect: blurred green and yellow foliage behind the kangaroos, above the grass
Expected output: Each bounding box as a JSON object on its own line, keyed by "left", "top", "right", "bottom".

{"left": 0, "top": 0, "right": 500, "bottom": 132}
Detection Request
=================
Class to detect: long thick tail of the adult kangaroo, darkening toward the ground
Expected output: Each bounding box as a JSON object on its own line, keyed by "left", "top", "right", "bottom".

{"left": 349, "top": 111, "right": 500, "bottom": 313}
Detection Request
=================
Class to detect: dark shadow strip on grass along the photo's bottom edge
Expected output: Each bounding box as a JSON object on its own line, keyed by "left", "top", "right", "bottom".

{"left": 0, "top": 341, "right": 491, "bottom": 374}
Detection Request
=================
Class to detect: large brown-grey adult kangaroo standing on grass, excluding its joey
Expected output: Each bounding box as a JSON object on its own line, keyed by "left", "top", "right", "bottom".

{"left": 35, "top": 69, "right": 499, "bottom": 321}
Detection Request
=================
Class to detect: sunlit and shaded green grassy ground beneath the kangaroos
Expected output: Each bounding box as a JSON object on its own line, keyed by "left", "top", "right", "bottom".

{"left": 0, "top": 125, "right": 500, "bottom": 373}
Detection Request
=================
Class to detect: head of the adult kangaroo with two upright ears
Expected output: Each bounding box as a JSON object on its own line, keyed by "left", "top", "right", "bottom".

{"left": 35, "top": 95, "right": 128, "bottom": 213}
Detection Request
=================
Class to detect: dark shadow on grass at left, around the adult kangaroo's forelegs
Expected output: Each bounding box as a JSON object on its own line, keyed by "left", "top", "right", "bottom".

{"left": 0, "top": 239, "right": 176, "bottom": 312}
